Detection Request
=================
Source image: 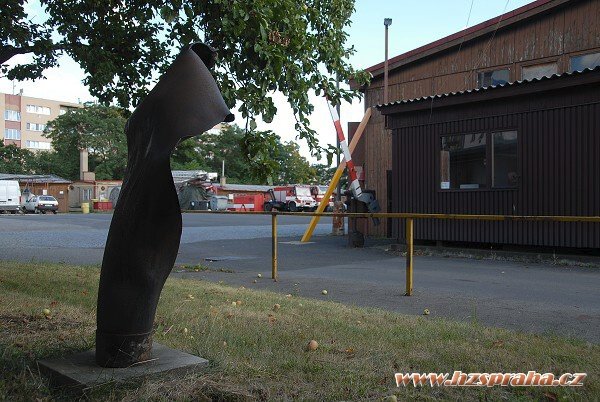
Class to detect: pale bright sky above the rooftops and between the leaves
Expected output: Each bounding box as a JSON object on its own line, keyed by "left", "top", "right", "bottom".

{"left": 0, "top": 0, "right": 531, "bottom": 162}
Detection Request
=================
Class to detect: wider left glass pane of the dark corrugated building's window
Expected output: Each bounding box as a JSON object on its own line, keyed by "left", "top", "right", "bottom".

{"left": 440, "top": 133, "right": 488, "bottom": 189}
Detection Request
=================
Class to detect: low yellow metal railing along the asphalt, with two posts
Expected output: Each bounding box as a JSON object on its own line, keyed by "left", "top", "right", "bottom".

{"left": 186, "top": 211, "right": 600, "bottom": 296}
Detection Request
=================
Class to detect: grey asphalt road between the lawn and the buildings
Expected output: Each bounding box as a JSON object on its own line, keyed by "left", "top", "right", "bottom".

{"left": 0, "top": 214, "right": 600, "bottom": 343}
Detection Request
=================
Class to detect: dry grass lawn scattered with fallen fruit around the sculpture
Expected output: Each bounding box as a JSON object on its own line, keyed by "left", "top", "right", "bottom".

{"left": 0, "top": 261, "right": 600, "bottom": 400}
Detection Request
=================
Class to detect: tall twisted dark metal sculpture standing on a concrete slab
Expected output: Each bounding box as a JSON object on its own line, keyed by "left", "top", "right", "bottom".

{"left": 96, "top": 44, "right": 233, "bottom": 367}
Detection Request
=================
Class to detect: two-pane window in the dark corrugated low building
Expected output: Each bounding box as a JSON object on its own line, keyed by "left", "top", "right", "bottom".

{"left": 440, "top": 131, "right": 519, "bottom": 190}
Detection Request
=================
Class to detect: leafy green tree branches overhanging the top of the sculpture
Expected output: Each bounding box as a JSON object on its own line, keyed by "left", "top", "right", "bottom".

{"left": 0, "top": 0, "right": 368, "bottom": 159}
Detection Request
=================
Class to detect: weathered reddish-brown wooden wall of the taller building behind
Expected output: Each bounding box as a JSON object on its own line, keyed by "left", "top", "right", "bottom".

{"left": 363, "top": 0, "right": 600, "bottom": 235}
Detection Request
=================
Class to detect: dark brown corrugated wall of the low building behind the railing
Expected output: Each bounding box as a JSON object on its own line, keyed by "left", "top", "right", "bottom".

{"left": 389, "top": 85, "right": 600, "bottom": 248}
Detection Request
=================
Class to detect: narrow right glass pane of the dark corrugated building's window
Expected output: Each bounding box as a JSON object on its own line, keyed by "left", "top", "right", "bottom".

{"left": 492, "top": 131, "right": 519, "bottom": 187}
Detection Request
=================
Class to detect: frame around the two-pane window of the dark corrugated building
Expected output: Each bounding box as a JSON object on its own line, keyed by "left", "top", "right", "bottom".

{"left": 434, "top": 127, "right": 522, "bottom": 193}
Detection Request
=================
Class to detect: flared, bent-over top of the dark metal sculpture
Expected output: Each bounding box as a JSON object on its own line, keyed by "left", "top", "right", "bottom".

{"left": 130, "top": 43, "right": 234, "bottom": 153}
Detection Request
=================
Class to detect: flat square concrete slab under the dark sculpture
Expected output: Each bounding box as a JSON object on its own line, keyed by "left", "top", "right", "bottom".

{"left": 38, "top": 342, "right": 208, "bottom": 392}
